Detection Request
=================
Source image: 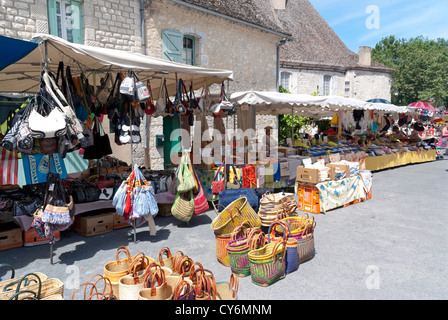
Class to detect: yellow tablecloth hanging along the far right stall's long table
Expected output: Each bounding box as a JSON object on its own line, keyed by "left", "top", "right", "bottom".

{"left": 365, "top": 150, "right": 436, "bottom": 171}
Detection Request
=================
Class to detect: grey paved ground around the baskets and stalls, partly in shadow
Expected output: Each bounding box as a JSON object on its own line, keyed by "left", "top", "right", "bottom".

{"left": 0, "top": 157, "right": 448, "bottom": 300}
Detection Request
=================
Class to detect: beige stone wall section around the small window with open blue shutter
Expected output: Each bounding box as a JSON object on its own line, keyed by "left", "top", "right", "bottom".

{"left": 145, "top": 0, "right": 280, "bottom": 168}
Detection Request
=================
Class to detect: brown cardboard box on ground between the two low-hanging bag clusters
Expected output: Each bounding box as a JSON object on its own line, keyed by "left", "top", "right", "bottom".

{"left": 73, "top": 211, "right": 114, "bottom": 237}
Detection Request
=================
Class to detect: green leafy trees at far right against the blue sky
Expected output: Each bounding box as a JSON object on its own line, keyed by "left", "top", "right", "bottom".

{"left": 372, "top": 36, "right": 448, "bottom": 106}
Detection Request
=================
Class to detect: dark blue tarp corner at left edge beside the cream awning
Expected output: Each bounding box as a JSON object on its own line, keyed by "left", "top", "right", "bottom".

{"left": 0, "top": 36, "right": 39, "bottom": 71}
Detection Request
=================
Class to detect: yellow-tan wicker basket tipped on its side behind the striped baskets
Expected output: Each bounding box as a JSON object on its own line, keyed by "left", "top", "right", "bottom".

{"left": 211, "top": 197, "right": 261, "bottom": 235}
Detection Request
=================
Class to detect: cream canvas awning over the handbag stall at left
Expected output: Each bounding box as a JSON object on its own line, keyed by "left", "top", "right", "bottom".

{"left": 0, "top": 34, "right": 233, "bottom": 99}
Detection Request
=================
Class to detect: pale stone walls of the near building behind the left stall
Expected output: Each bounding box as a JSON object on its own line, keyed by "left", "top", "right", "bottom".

{"left": 0, "top": 0, "right": 281, "bottom": 169}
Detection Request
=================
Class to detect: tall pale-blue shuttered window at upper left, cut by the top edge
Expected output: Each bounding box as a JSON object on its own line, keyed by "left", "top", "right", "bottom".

{"left": 47, "top": 0, "right": 83, "bottom": 44}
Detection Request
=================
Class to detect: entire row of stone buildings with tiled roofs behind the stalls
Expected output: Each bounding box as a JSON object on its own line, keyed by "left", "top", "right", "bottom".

{"left": 0, "top": 0, "right": 391, "bottom": 169}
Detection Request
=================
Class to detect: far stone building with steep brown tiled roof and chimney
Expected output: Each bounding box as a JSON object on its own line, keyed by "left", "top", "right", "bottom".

{"left": 277, "top": 0, "right": 393, "bottom": 101}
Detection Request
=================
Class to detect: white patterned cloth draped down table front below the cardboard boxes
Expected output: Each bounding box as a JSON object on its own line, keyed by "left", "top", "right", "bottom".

{"left": 316, "top": 175, "right": 365, "bottom": 212}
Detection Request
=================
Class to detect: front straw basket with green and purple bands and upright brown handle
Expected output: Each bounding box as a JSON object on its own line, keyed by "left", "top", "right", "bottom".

{"left": 248, "top": 222, "right": 286, "bottom": 287}
